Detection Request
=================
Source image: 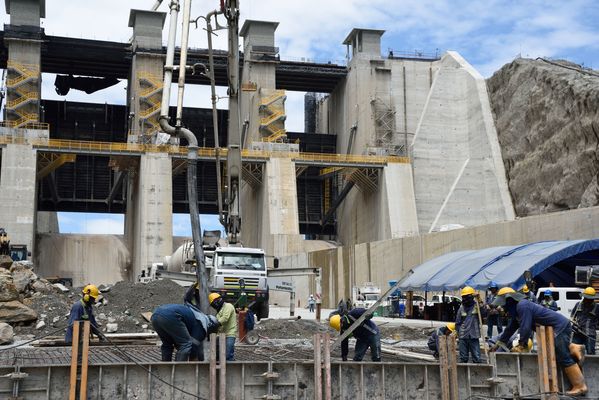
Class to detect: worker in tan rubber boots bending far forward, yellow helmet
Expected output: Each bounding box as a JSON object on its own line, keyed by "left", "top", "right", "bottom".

{"left": 491, "top": 287, "right": 587, "bottom": 396}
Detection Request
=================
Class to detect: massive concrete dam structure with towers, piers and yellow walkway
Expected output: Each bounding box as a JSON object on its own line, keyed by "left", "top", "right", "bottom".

{"left": 0, "top": 1, "right": 514, "bottom": 290}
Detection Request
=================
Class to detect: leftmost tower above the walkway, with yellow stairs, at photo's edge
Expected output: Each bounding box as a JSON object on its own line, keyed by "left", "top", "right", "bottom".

{"left": 4, "top": 0, "right": 46, "bottom": 127}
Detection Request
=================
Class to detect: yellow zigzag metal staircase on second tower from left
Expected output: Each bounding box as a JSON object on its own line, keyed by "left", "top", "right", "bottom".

{"left": 137, "top": 72, "right": 163, "bottom": 135}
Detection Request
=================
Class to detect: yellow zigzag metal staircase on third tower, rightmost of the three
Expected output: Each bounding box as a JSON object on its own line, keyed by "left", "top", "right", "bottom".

{"left": 260, "top": 90, "right": 287, "bottom": 142}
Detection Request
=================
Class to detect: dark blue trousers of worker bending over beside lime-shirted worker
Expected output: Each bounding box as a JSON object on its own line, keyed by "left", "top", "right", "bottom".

{"left": 152, "top": 313, "right": 204, "bottom": 361}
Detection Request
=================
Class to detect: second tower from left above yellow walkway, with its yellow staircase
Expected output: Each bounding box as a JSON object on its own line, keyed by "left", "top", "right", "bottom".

{"left": 127, "top": 10, "right": 166, "bottom": 143}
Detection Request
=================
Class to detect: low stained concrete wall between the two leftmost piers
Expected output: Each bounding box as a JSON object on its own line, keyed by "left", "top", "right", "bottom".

{"left": 35, "top": 233, "right": 131, "bottom": 286}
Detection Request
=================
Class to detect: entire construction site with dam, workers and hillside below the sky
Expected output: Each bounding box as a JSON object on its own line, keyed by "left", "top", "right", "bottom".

{"left": 0, "top": 0, "right": 599, "bottom": 400}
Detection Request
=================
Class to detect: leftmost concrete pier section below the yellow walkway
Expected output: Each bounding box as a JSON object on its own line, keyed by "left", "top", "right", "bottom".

{"left": 0, "top": 144, "right": 37, "bottom": 254}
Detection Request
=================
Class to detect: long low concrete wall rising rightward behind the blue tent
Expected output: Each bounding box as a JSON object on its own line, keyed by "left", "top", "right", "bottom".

{"left": 281, "top": 207, "right": 599, "bottom": 307}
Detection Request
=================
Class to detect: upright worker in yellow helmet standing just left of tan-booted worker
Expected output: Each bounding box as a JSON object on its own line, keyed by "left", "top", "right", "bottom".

{"left": 455, "top": 286, "right": 480, "bottom": 363}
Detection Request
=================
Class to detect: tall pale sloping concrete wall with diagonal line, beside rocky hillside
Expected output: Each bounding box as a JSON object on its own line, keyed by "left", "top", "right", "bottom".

{"left": 412, "top": 52, "right": 515, "bottom": 232}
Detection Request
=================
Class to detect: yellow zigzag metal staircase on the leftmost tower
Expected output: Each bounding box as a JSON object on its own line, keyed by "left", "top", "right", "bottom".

{"left": 6, "top": 61, "right": 40, "bottom": 128}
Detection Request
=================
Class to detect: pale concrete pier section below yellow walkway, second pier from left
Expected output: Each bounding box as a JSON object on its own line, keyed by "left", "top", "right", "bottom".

{"left": 125, "top": 153, "right": 173, "bottom": 280}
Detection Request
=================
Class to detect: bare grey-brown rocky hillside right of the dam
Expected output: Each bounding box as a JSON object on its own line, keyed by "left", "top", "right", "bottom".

{"left": 487, "top": 58, "right": 599, "bottom": 216}
